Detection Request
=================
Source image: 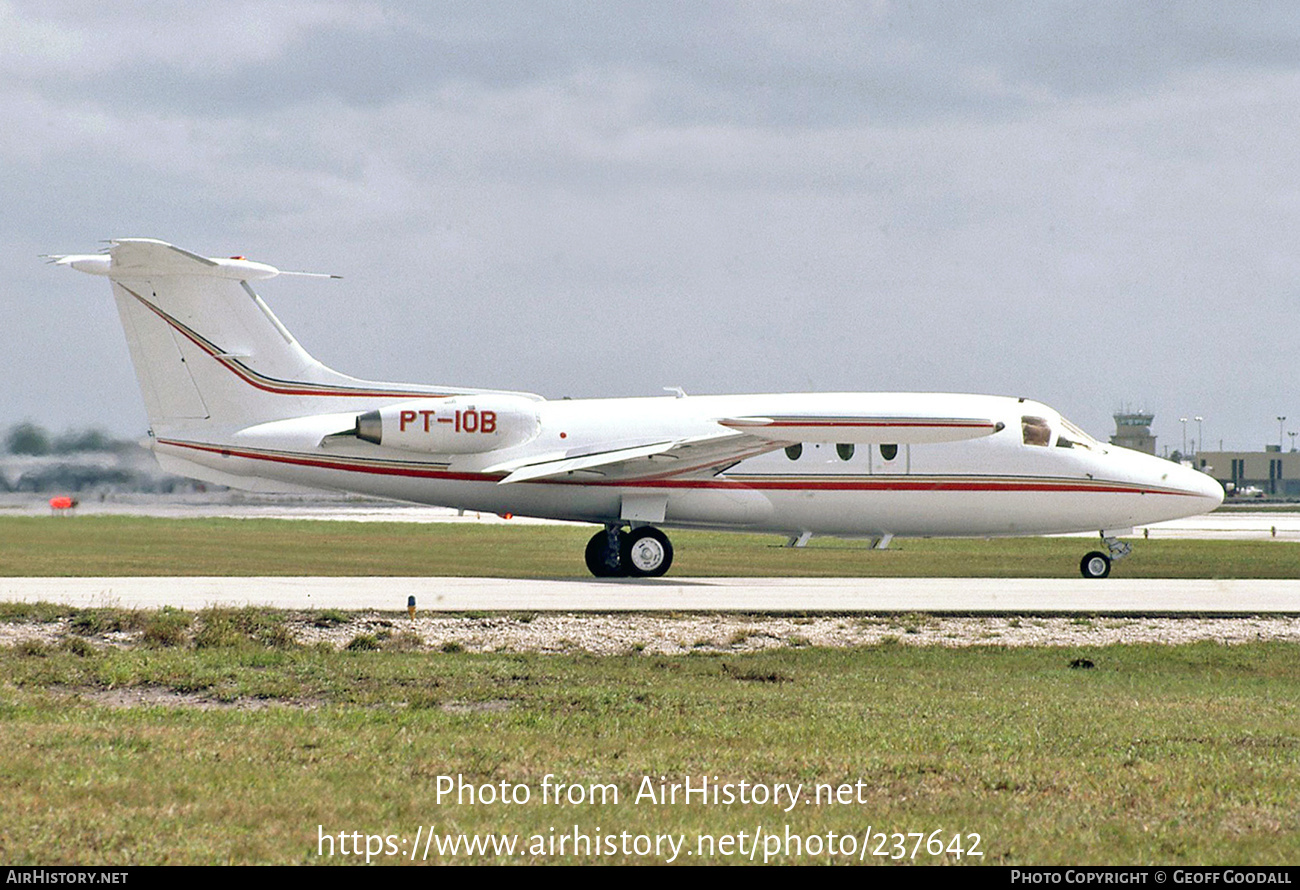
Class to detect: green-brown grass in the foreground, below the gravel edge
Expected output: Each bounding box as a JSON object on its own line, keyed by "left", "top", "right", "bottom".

{"left": 0, "top": 611, "right": 1300, "bottom": 864}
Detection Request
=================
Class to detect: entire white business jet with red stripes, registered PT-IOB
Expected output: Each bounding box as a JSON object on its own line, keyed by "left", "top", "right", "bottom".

{"left": 52, "top": 238, "right": 1223, "bottom": 578}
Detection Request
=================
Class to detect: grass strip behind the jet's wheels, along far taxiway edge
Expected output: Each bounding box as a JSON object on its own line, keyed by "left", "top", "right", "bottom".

{"left": 0, "top": 516, "right": 1300, "bottom": 578}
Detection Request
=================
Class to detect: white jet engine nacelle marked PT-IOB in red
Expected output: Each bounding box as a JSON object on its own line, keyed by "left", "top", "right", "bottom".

{"left": 356, "top": 395, "right": 542, "bottom": 455}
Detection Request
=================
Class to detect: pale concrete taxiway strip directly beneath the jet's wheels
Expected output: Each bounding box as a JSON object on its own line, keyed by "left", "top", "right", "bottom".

{"left": 0, "top": 577, "right": 1300, "bottom": 615}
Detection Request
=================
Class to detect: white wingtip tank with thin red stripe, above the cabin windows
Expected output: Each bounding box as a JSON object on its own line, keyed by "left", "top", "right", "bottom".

{"left": 718, "top": 414, "right": 1002, "bottom": 444}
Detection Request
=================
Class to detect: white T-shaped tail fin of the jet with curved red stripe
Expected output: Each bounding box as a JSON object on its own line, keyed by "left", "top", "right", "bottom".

{"left": 55, "top": 238, "right": 464, "bottom": 435}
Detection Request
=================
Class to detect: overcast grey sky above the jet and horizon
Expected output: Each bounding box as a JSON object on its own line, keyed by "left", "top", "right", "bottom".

{"left": 0, "top": 0, "right": 1300, "bottom": 448}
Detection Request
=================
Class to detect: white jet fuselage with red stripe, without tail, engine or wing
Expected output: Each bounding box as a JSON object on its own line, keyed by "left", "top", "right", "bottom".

{"left": 156, "top": 394, "right": 1222, "bottom": 537}
